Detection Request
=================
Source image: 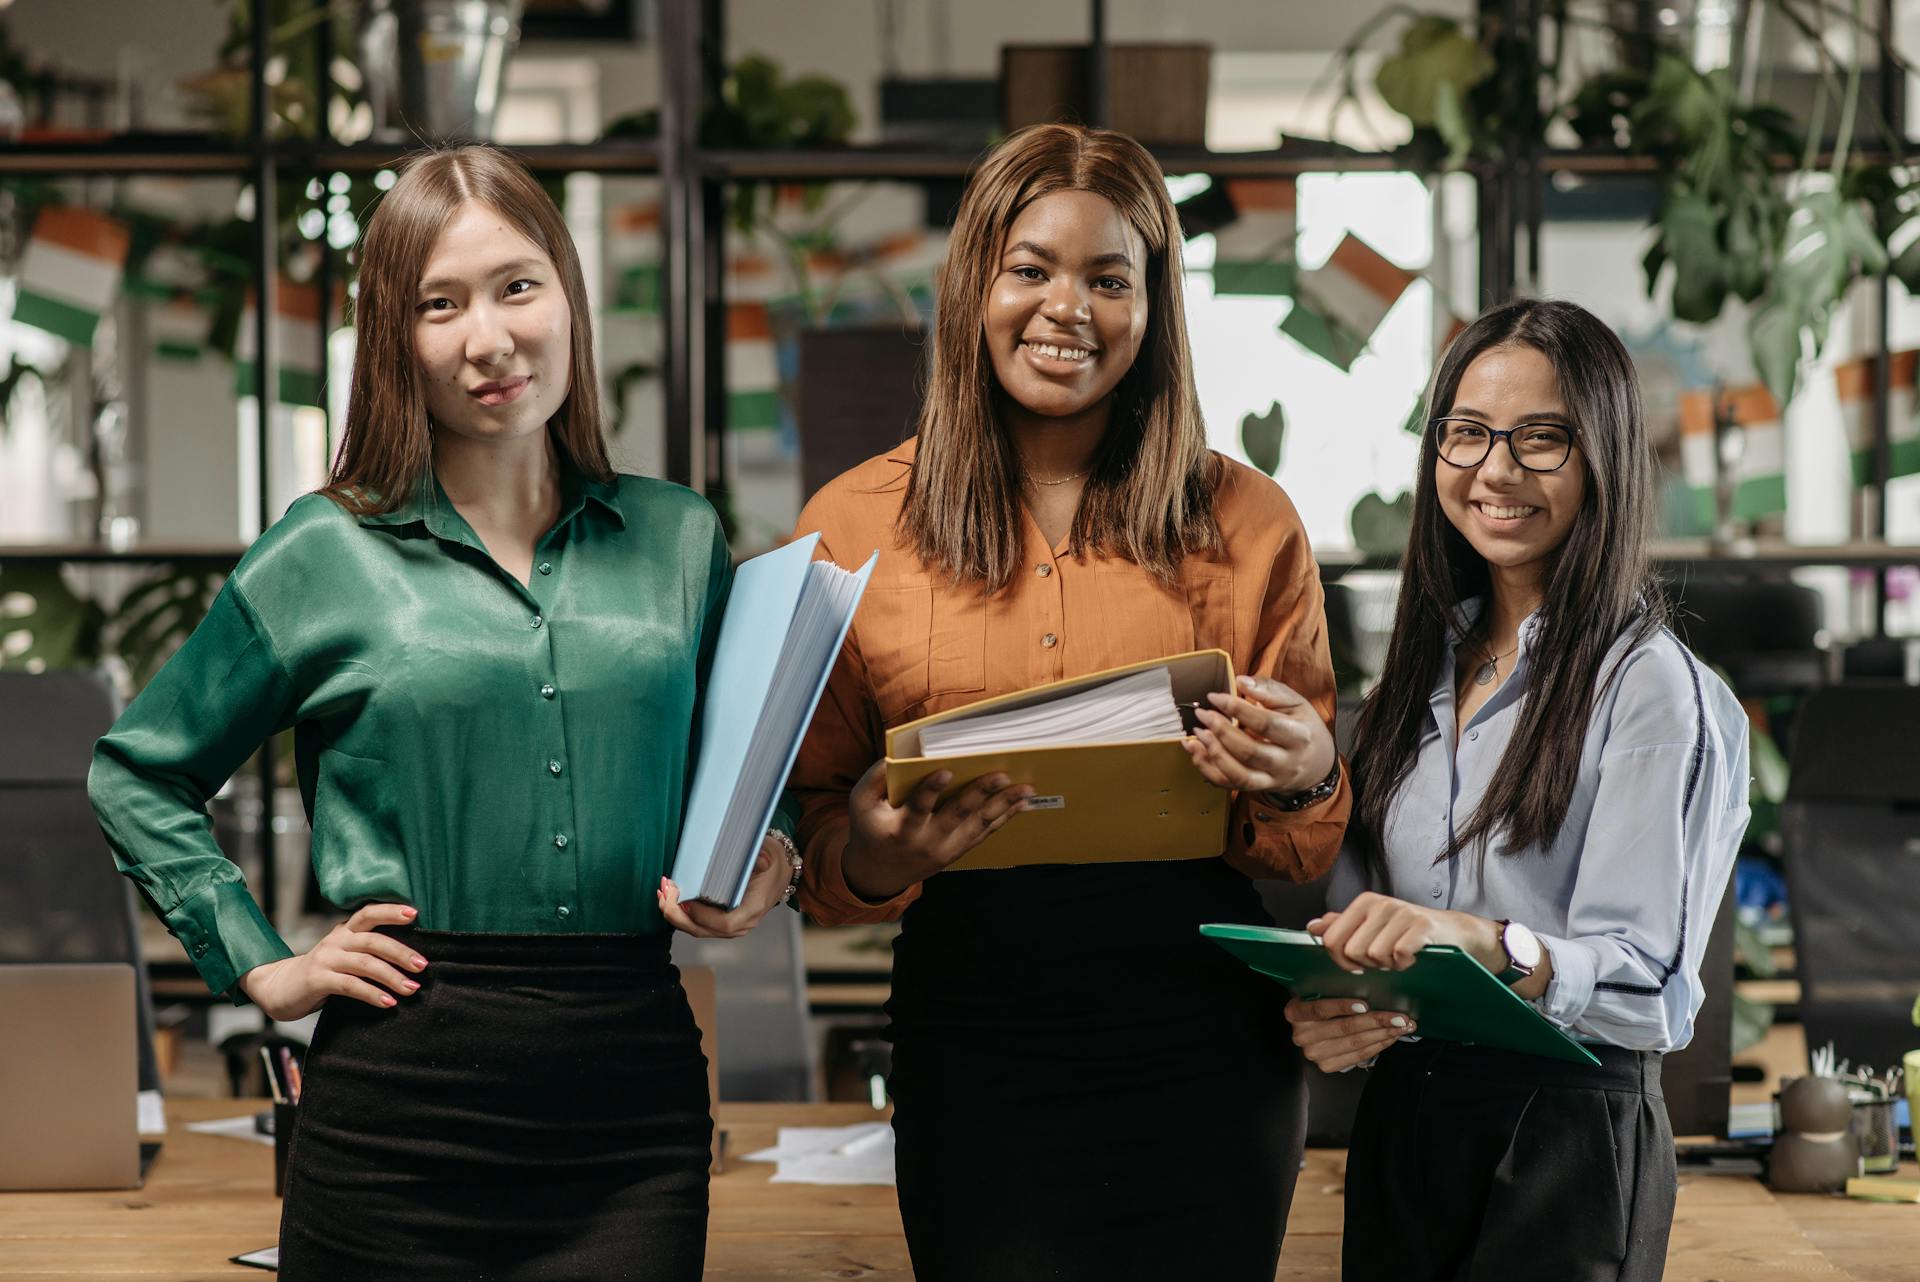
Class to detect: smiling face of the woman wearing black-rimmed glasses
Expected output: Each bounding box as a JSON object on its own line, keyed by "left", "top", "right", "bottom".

{"left": 1434, "top": 345, "right": 1586, "bottom": 578}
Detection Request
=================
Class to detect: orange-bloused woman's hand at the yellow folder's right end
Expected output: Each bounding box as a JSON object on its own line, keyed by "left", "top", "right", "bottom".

{"left": 1183, "top": 677, "right": 1334, "bottom": 793}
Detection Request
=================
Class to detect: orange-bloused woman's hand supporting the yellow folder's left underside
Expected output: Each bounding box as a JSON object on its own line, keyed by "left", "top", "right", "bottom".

{"left": 841, "top": 762, "right": 1033, "bottom": 902}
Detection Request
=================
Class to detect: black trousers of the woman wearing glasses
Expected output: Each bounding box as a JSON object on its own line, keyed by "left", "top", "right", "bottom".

{"left": 1342, "top": 1038, "right": 1676, "bottom": 1282}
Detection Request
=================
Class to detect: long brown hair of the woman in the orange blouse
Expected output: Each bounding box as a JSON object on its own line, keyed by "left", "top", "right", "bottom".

{"left": 900, "top": 125, "right": 1219, "bottom": 591}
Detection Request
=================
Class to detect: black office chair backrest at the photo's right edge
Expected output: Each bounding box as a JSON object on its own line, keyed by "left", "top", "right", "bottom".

{"left": 1780, "top": 683, "right": 1920, "bottom": 1071}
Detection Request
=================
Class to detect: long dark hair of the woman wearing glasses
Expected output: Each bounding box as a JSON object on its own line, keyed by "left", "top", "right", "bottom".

{"left": 1352, "top": 299, "right": 1667, "bottom": 887}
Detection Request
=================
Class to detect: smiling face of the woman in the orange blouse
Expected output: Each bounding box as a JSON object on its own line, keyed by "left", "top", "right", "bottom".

{"left": 983, "top": 192, "right": 1146, "bottom": 418}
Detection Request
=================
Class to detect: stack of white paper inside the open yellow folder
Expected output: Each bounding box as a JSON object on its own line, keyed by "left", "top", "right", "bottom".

{"left": 920, "top": 668, "right": 1185, "bottom": 756}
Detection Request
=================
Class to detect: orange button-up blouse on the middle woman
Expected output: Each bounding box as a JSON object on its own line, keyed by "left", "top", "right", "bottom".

{"left": 789, "top": 441, "right": 1352, "bottom": 925}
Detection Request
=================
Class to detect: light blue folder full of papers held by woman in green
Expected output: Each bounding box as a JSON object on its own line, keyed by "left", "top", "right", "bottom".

{"left": 672, "top": 534, "right": 879, "bottom": 908}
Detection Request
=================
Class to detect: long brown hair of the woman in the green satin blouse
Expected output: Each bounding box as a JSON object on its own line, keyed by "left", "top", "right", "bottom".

{"left": 321, "top": 146, "right": 612, "bottom": 516}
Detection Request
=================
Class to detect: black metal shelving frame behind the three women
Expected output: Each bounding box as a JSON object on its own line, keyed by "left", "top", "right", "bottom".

{"left": 11, "top": 0, "right": 1920, "bottom": 921}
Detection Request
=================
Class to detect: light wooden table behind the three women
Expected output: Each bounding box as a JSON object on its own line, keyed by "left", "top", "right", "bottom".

{"left": 0, "top": 1100, "right": 1920, "bottom": 1282}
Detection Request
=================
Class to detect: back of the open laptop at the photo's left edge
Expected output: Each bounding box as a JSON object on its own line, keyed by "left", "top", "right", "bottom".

{"left": 0, "top": 963, "right": 152, "bottom": 1192}
